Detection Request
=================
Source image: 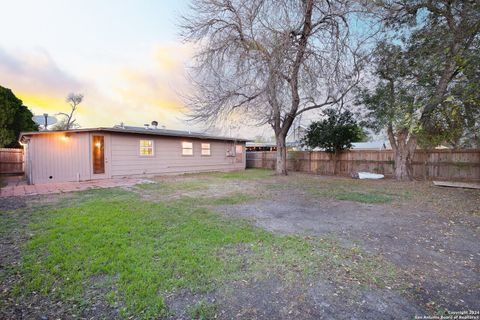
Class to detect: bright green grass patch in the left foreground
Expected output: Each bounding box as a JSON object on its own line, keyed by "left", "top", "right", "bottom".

{"left": 16, "top": 190, "right": 269, "bottom": 317}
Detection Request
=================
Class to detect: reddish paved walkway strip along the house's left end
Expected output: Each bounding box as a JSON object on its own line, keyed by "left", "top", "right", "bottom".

{"left": 0, "top": 178, "right": 142, "bottom": 198}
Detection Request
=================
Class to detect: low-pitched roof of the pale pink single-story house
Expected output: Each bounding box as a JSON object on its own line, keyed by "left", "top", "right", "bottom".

{"left": 20, "top": 126, "right": 251, "bottom": 142}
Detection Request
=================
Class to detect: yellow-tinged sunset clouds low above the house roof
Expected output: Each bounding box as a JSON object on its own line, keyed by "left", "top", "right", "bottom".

{"left": 0, "top": 44, "right": 195, "bottom": 128}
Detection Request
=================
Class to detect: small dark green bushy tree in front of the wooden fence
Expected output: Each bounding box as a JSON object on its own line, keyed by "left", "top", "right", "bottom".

{"left": 303, "top": 109, "right": 366, "bottom": 154}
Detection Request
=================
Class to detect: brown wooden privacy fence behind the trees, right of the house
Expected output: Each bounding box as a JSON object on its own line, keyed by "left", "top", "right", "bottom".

{"left": 247, "top": 149, "right": 480, "bottom": 181}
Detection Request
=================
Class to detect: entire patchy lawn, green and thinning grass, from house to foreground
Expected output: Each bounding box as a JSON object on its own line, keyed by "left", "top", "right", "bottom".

{"left": 0, "top": 170, "right": 396, "bottom": 319}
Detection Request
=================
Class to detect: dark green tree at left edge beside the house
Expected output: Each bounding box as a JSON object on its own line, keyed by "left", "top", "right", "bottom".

{"left": 0, "top": 86, "right": 38, "bottom": 148}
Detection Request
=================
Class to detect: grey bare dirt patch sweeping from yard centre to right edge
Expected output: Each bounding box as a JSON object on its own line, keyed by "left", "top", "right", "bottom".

{"left": 217, "top": 186, "right": 480, "bottom": 311}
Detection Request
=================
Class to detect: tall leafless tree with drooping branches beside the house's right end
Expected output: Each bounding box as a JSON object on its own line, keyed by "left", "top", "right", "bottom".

{"left": 182, "top": 0, "right": 370, "bottom": 174}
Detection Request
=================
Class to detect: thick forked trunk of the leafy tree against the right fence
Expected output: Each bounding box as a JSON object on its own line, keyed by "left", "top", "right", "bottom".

{"left": 387, "top": 128, "right": 417, "bottom": 181}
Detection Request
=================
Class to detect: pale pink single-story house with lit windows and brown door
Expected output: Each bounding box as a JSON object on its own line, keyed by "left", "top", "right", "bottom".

{"left": 20, "top": 126, "right": 247, "bottom": 184}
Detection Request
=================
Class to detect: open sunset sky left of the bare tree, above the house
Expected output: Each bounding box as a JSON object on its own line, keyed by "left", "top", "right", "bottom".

{"left": 0, "top": 0, "right": 223, "bottom": 129}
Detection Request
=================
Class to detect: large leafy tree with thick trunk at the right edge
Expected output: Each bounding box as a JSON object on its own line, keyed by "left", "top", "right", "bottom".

{"left": 360, "top": 0, "right": 480, "bottom": 180}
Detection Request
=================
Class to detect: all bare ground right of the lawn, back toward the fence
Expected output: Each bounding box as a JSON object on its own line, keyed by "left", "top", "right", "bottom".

{"left": 217, "top": 174, "right": 480, "bottom": 318}
